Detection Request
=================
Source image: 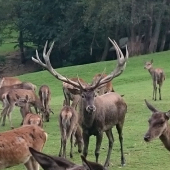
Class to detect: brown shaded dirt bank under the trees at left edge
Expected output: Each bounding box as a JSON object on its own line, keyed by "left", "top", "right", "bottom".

{"left": 0, "top": 51, "right": 40, "bottom": 76}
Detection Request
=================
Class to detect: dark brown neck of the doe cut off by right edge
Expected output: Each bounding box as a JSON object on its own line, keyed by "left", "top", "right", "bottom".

{"left": 159, "top": 124, "right": 170, "bottom": 151}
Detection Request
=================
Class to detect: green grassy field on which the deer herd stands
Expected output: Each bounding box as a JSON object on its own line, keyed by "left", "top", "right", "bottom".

{"left": 0, "top": 51, "right": 170, "bottom": 170}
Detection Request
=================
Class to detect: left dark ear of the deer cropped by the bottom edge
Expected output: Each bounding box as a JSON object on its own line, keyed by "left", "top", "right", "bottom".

{"left": 29, "top": 147, "right": 60, "bottom": 170}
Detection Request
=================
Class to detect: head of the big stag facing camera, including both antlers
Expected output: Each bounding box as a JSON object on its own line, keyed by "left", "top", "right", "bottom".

{"left": 32, "top": 38, "right": 129, "bottom": 113}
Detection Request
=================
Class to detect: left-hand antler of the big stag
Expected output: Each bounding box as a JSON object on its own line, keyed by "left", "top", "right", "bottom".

{"left": 32, "top": 41, "right": 85, "bottom": 89}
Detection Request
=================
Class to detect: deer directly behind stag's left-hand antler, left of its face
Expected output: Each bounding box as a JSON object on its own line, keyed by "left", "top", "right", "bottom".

{"left": 63, "top": 78, "right": 86, "bottom": 109}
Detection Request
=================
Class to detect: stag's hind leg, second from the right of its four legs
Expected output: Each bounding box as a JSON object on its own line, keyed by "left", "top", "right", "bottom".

{"left": 104, "top": 129, "right": 114, "bottom": 167}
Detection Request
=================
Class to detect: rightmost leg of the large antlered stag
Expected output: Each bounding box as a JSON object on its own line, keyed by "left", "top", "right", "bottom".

{"left": 116, "top": 124, "right": 125, "bottom": 166}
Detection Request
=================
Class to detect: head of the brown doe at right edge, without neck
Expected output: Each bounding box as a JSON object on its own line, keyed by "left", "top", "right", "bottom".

{"left": 144, "top": 100, "right": 170, "bottom": 142}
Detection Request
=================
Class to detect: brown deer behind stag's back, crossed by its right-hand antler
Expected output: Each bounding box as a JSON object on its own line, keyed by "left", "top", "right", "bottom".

{"left": 92, "top": 74, "right": 114, "bottom": 96}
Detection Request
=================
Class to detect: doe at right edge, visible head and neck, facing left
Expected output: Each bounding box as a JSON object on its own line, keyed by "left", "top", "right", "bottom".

{"left": 144, "top": 100, "right": 170, "bottom": 151}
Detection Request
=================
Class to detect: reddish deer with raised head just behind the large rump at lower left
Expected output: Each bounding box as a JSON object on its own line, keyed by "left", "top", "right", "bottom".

{"left": 15, "top": 94, "right": 43, "bottom": 128}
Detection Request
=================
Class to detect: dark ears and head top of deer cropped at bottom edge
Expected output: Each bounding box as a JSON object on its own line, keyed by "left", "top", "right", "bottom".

{"left": 29, "top": 147, "right": 106, "bottom": 170}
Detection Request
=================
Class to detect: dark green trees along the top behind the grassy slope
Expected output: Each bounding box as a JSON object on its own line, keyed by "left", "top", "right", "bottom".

{"left": 0, "top": 0, "right": 170, "bottom": 67}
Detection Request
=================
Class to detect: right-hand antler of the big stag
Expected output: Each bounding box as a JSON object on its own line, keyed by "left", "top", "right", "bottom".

{"left": 90, "top": 37, "right": 129, "bottom": 89}
